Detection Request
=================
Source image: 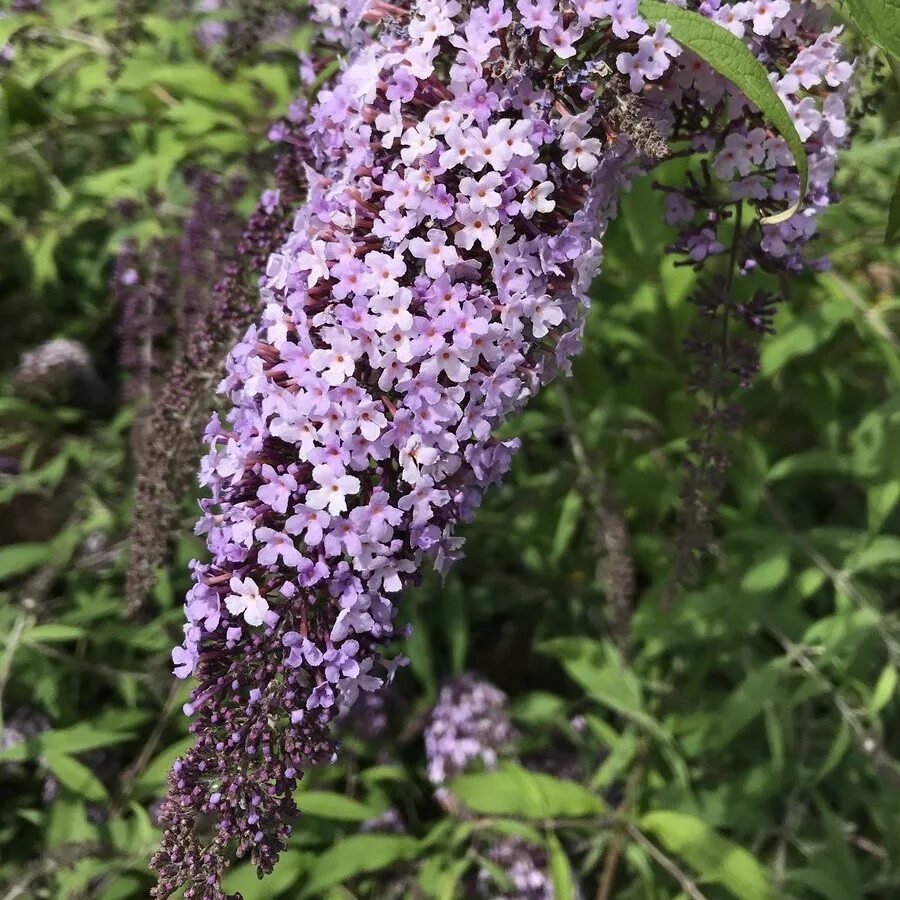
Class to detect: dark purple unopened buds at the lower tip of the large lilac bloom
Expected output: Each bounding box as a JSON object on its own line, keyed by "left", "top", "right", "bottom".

{"left": 152, "top": 634, "right": 334, "bottom": 900}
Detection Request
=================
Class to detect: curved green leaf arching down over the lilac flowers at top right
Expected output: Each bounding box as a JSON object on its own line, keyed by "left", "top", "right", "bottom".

{"left": 639, "top": 0, "right": 808, "bottom": 225}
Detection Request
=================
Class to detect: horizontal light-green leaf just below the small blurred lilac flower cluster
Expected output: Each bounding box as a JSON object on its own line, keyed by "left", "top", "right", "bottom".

{"left": 449, "top": 763, "right": 605, "bottom": 819}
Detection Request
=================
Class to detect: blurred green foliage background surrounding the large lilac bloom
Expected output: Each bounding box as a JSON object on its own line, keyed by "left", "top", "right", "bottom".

{"left": 0, "top": 0, "right": 900, "bottom": 900}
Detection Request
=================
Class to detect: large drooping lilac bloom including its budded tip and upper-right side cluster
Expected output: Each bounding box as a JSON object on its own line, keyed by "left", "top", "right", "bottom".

{"left": 153, "top": 0, "right": 850, "bottom": 900}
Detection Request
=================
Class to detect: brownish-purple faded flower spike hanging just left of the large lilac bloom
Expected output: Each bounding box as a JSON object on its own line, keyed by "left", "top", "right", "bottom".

{"left": 125, "top": 122, "right": 306, "bottom": 613}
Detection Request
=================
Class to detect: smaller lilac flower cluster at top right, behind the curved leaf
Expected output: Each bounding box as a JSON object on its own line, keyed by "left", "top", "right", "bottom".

{"left": 660, "top": 0, "right": 853, "bottom": 275}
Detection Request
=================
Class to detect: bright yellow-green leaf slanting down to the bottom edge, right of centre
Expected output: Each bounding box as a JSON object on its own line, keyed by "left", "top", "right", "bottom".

{"left": 641, "top": 810, "right": 775, "bottom": 900}
